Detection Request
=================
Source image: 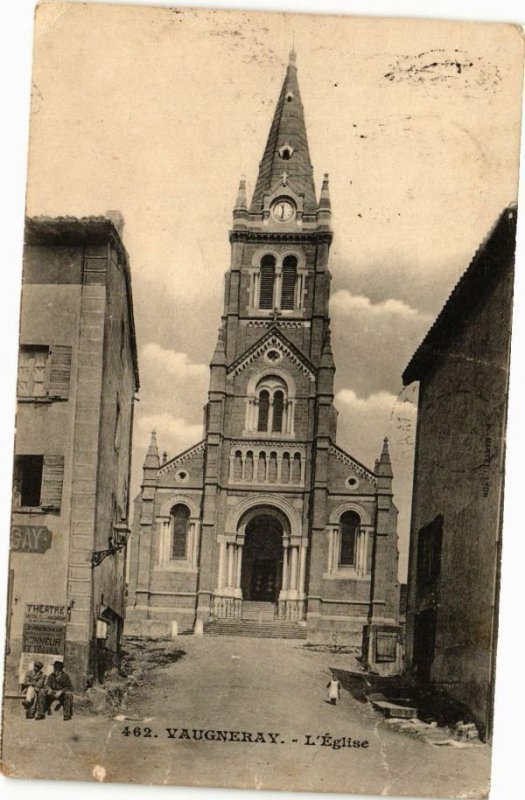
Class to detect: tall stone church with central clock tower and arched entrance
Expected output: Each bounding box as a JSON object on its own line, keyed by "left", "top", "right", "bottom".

{"left": 126, "top": 51, "right": 399, "bottom": 664}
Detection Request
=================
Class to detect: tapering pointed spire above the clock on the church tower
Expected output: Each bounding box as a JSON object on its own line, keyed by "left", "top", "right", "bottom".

{"left": 250, "top": 50, "right": 317, "bottom": 214}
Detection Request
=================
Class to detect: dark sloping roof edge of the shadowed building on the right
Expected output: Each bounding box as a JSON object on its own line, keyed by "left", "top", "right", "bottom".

{"left": 403, "top": 205, "right": 518, "bottom": 386}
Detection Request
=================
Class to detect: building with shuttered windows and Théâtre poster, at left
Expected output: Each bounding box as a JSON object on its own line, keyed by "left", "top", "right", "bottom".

{"left": 6, "top": 212, "right": 139, "bottom": 689}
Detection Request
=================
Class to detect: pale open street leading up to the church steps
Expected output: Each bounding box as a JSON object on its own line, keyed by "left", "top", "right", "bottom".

{"left": 3, "top": 636, "right": 490, "bottom": 797}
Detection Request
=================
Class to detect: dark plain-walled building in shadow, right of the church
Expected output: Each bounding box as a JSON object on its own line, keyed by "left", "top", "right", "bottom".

{"left": 403, "top": 207, "right": 517, "bottom": 738}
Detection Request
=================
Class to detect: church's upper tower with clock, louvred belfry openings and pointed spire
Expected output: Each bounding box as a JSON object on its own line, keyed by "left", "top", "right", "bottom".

{"left": 220, "top": 51, "right": 332, "bottom": 366}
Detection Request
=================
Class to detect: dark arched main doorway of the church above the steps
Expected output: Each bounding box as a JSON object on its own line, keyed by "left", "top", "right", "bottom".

{"left": 241, "top": 513, "right": 283, "bottom": 603}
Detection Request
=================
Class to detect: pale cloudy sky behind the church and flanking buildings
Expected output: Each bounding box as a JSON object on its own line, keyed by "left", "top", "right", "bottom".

{"left": 20, "top": 3, "right": 522, "bottom": 578}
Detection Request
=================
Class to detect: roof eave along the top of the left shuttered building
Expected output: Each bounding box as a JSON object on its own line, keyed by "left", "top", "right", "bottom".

{"left": 24, "top": 216, "right": 140, "bottom": 391}
